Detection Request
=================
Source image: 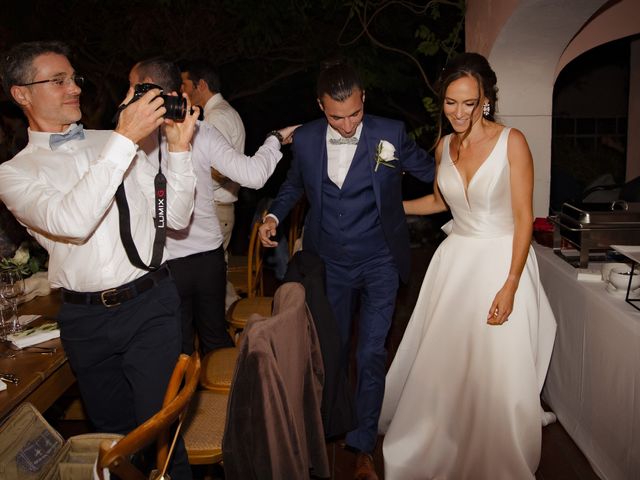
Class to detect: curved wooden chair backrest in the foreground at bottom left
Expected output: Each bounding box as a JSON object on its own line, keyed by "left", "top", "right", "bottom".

{"left": 97, "top": 352, "right": 200, "bottom": 480}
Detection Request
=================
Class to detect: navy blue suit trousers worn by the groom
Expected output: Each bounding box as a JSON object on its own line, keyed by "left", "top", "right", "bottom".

{"left": 325, "top": 255, "right": 399, "bottom": 452}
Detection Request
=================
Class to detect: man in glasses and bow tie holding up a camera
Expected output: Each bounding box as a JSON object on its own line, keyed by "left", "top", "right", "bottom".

{"left": 0, "top": 42, "right": 197, "bottom": 479}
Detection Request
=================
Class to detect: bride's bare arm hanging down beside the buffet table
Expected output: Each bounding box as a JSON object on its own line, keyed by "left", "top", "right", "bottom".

{"left": 487, "top": 128, "right": 533, "bottom": 325}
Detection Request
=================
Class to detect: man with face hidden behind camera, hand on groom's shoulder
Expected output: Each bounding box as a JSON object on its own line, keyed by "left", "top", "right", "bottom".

{"left": 129, "top": 57, "right": 297, "bottom": 355}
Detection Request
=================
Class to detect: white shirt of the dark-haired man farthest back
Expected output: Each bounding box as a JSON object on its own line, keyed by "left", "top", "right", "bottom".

{"left": 203, "top": 93, "right": 245, "bottom": 203}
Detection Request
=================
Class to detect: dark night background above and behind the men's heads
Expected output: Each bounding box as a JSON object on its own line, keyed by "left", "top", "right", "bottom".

{"left": 0, "top": 0, "right": 463, "bottom": 251}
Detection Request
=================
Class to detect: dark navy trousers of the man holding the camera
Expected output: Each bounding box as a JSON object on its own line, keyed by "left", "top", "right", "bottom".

{"left": 58, "top": 277, "right": 191, "bottom": 480}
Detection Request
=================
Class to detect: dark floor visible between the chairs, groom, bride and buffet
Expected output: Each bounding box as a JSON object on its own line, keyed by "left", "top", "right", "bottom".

{"left": 50, "top": 235, "right": 598, "bottom": 480}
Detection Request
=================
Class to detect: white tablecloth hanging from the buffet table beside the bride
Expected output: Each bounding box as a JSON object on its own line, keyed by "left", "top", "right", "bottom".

{"left": 534, "top": 245, "right": 640, "bottom": 480}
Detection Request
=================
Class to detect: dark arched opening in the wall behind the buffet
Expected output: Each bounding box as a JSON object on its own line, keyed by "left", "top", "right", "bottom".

{"left": 550, "top": 37, "right": 637, "bottom": 211}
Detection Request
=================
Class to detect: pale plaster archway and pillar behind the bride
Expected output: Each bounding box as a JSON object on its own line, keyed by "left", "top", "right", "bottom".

{"left": 466, "top": 0, "right": 640, "bottom": 216}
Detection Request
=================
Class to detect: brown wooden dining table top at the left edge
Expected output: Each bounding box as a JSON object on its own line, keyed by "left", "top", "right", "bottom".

{"left": 0, "top": 290, "right": 75, "bottom": 421}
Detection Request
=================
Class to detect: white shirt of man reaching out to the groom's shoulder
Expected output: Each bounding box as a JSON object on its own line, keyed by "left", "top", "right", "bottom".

{"left": 146, "top": 122, "right": 282, "bottom": 258}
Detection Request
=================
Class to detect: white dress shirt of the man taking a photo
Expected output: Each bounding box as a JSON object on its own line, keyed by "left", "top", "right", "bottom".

{"left": 0, "top": 125, "right": 195, "bottom": 292}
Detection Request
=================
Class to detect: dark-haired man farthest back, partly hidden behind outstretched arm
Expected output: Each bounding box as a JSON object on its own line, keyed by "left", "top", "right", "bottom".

{"left": 182, "top": 60, "right": 246, "bottom": 308}
